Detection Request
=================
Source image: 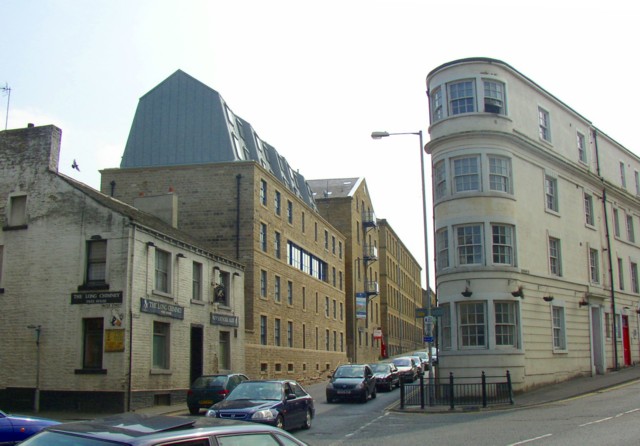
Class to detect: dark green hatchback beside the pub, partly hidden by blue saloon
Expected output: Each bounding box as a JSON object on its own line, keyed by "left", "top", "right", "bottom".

{"left": 187, "top": 373, "right": 249, "bottom": 415}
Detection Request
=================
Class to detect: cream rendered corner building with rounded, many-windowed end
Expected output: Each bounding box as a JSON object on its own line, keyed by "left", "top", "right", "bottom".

{"left": 426, "top": 58, "right": 640, "bottom": 391}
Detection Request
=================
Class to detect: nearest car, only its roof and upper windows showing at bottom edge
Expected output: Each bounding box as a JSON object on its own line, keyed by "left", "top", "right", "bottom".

{"left": 20, "top": 413, "right": 306, "bottom": 446}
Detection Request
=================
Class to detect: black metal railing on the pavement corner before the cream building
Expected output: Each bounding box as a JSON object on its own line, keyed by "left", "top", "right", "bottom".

{"left": 400, "top": 370, "right": 513, "bottom": 409}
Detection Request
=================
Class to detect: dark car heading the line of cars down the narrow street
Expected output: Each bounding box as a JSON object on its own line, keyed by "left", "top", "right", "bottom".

{"left": 326, "top": 364, "right": 376, "bottom": 403}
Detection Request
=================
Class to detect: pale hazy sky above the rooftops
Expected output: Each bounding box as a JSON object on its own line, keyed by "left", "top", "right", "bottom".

{"left": 0, "top": 0, "right": 640, "bottom": 287}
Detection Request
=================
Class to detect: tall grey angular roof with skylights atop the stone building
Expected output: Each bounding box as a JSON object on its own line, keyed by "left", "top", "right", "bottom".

{"left": 120, "top": 70, "right": 316, "bottom": 209}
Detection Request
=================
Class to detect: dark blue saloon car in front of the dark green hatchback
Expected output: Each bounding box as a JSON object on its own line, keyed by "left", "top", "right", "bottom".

{"left": 207, "top": 380, "right": 315, "bottom": 430}
